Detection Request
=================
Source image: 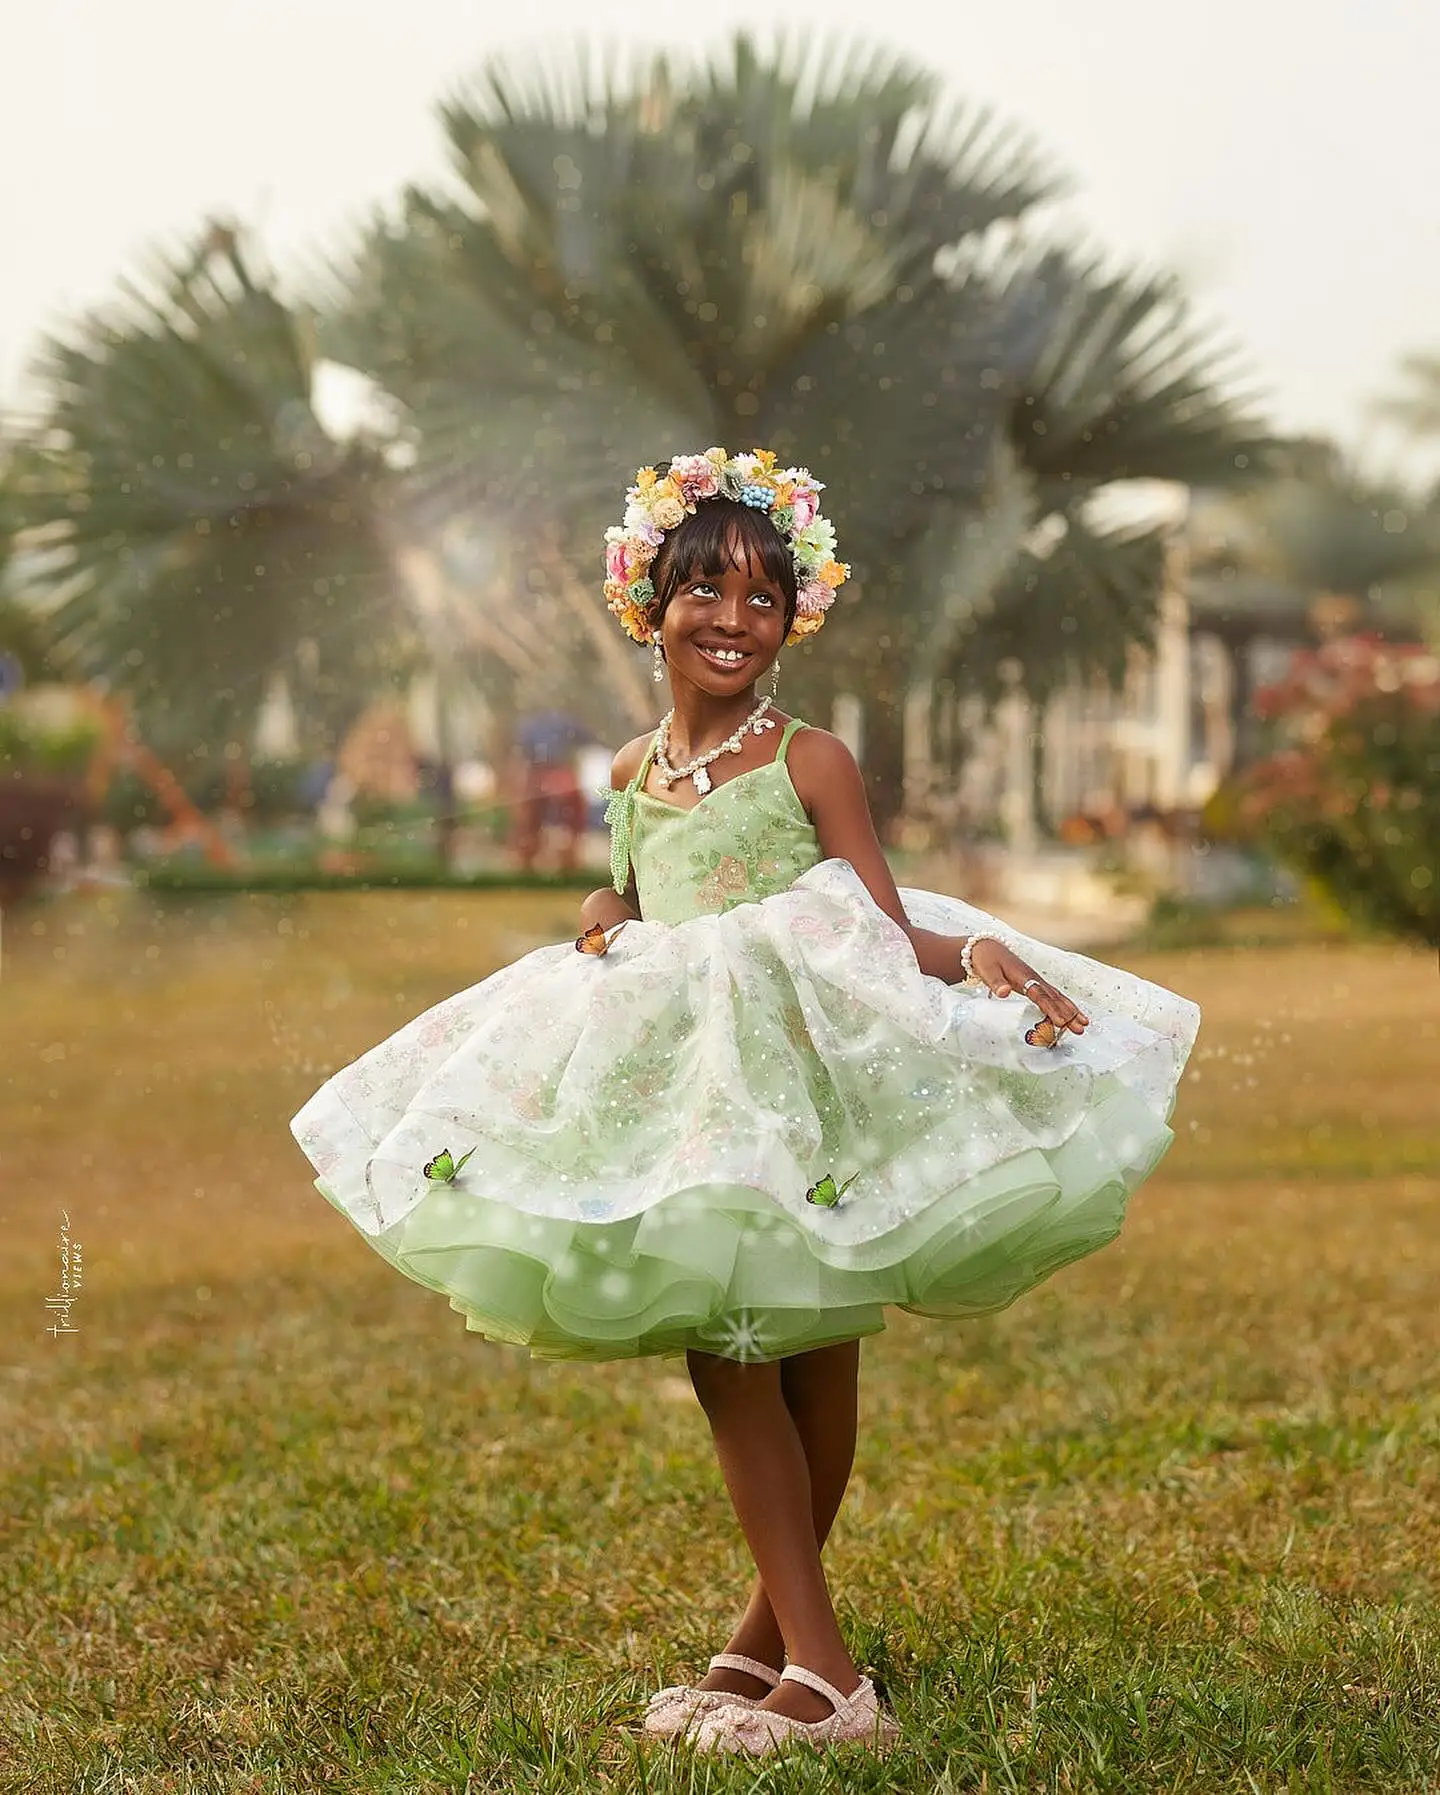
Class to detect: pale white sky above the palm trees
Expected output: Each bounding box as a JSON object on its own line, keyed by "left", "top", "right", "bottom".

{"left": 0, "top": 0, "right": 1440, "bottom": 481}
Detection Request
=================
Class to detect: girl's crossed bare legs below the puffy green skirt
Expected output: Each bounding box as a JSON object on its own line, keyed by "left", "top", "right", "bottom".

{"left": 688, "top": 1341, "right": 860, "bottom": 1720}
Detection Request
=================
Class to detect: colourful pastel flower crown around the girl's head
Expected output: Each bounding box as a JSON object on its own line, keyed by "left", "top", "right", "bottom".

{"left": 605, "top": 449, "right": 849, "bottom": 648}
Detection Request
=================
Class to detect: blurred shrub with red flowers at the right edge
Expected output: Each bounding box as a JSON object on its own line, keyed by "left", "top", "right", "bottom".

{"left": 1239, "top": 635, "right": 1440, "bottom": 946}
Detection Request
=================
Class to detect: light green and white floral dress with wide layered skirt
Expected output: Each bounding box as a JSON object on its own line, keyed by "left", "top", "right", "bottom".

{"left": 291, "top": 722, "right": 1199, "bottom": 1361}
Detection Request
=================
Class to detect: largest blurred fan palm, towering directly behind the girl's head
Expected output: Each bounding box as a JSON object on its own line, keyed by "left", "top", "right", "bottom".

{"left": 327, "top": 36, "right": 1257, "bottom": 822}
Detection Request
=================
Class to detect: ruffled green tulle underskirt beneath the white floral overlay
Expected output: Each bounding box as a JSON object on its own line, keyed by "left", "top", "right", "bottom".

{"left": 316, "top": 1081, "right": 1172, "bottom": 1362}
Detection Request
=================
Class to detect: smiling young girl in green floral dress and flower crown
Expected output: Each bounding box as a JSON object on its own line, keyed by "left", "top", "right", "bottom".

{"left": 291, "top": 449, "right": 1199, "bottom": 1754}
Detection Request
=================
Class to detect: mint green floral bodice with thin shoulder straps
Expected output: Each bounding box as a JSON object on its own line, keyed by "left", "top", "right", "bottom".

{"left": 605, "top": 716, "right": 824, "bottom": 923}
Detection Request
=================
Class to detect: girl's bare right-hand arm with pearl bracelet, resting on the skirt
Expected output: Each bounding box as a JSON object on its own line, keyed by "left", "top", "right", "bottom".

{"left": 788, "top": 729, "right": 1088, "bottom": 1034}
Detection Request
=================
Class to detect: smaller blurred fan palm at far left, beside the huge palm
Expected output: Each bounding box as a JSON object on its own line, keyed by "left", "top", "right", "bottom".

{"left": 22, "top": 224, "right": 404, "bottom": 752}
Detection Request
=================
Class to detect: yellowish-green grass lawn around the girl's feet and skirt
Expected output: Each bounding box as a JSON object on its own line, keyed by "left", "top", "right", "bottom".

{"left": 0, "top": 890, "right": 1440, "bottom": 1795}
